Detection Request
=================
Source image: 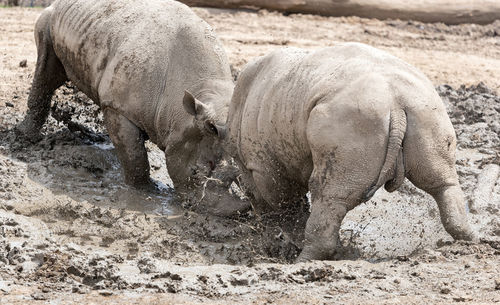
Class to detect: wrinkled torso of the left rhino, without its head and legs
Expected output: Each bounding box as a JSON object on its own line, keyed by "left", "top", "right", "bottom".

{"left": 47, "top": 0, "right": 231, "bottom": 142}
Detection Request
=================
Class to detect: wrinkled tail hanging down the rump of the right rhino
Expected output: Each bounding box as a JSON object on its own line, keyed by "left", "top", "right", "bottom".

{"left": 364, "top": 109, "right": 406, "bottom": 201}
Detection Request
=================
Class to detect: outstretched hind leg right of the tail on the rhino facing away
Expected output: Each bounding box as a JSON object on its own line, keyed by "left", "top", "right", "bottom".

{"left": 403, "top": 111, "right": 477, "bottom": 240}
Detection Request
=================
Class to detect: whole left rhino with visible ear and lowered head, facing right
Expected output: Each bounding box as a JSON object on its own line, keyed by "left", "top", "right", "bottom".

{"left": 18, "top": 0, "right": 238, "bottom": 207}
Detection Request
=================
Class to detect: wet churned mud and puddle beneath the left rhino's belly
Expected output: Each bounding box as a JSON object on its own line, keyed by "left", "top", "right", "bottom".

{"left": 5, "top": 83, "right": 183, "bottom": 215}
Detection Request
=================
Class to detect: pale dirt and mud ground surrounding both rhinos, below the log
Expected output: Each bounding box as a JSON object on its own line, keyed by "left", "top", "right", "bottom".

{"left": 0, "top": 8, "right": 500, "bottom": 304}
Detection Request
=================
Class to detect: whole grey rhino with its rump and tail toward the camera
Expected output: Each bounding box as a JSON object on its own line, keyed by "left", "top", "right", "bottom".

{"left": 215, "top": 43, "right": 475, "bottom": 261}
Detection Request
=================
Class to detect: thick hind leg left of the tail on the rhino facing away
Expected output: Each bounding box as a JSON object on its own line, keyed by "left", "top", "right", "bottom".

{"left": 297, "top": 98, "right": 388, "bottom": 261}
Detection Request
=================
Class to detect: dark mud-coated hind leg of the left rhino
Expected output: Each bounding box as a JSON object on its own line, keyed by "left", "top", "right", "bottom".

{"left": 17, "top": 11, "right": 68, "bottom": 139}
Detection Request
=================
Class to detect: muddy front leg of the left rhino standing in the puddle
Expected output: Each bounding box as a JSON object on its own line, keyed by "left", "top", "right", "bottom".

{"left": 104, "top": 108, "right": 151, "bottom": 188}
